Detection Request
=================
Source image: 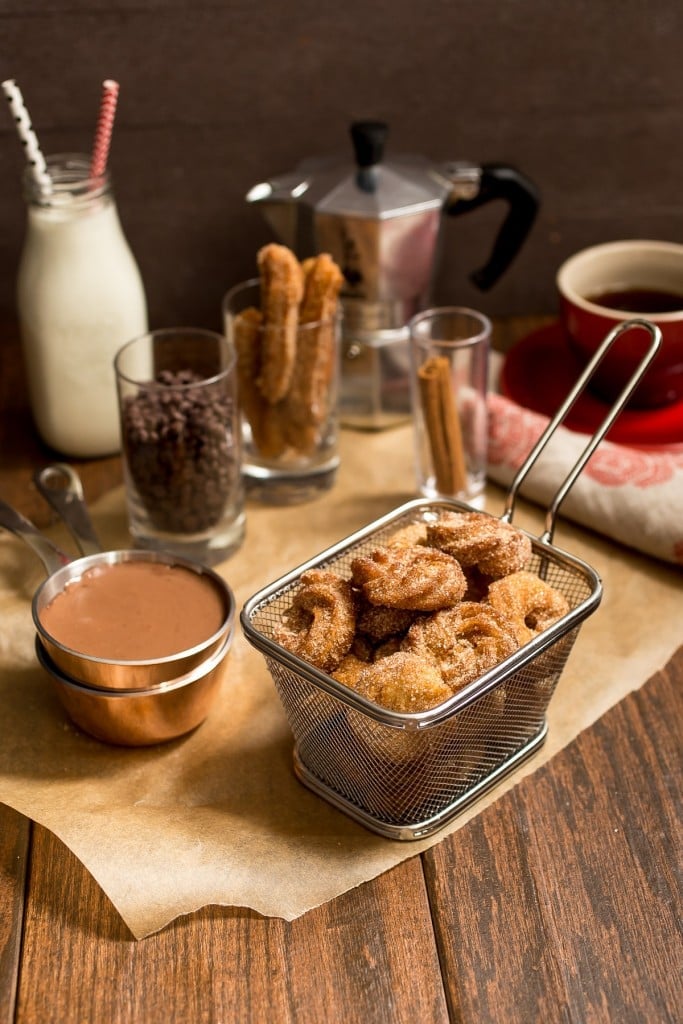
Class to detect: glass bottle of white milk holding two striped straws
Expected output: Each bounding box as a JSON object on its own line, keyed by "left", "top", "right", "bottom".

{"left": 17, "top": 155, "right": 147, "bottom": 458}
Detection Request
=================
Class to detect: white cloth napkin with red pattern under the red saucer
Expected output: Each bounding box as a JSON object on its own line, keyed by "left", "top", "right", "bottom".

{"left": 488, "top": 382, "right": 683, "bottom": 565}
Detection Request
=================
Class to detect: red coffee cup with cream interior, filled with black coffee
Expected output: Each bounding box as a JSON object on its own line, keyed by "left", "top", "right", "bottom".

{"left": 556, "top": 240, "right": 683, "bottom": 409}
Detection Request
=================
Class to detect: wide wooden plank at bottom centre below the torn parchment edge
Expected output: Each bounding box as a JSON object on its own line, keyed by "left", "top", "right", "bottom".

{"left": 16, "top": 826, "right": 449, "bottom": 1024}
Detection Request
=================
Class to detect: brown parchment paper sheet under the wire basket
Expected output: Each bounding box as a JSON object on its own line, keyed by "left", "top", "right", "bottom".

{"left": 0, "top": 426, "right": 683, "bottom": 938}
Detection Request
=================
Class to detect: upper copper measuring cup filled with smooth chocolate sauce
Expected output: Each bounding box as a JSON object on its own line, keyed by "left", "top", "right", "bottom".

{"left": 33, "top": 551, "right": 234, "bottom": 691}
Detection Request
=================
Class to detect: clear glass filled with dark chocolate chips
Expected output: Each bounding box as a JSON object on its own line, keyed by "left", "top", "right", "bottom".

{"left": 114, "top": 328, "right": 245, "bottom": 565}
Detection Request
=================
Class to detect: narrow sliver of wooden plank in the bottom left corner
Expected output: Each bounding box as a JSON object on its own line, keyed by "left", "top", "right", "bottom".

{"left": 0, "top": 804, "right": 31, "bottom": 1024}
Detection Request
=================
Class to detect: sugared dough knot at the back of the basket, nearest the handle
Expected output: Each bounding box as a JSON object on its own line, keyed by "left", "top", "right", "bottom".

{"left": 427, "top": 512, "right": 531, "bottom": 580}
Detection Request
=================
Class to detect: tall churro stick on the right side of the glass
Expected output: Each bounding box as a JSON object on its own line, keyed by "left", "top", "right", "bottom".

{"left": 286, "top": 253, "right": 343, "bottom": 451}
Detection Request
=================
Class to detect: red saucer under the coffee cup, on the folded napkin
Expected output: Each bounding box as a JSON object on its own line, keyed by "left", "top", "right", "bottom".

{"left": 501, "top": 323, "right": 683, "bottom": 444}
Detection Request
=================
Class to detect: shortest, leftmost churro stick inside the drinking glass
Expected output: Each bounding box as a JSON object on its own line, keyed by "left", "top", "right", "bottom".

{"left": 232, "top": 306, "right": 285, "bottom": 459}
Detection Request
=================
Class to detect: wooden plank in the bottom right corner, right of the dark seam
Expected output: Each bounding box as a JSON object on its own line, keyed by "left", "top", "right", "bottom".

{"left": 425, "top": 657, "right": 683, "bottom": 1024}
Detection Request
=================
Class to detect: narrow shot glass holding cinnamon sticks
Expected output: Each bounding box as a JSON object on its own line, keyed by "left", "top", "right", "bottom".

{"left": 410, "top": 306, "right": 490, "bottom": 507}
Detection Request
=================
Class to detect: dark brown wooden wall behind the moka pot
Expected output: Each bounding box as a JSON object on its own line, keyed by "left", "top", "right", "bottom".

{"left": 0, "top": 0, "right": 683, "bottom": 327}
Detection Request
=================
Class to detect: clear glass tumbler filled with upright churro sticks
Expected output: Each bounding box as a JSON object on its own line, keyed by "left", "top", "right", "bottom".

{"left": 223, "top": 243, "right": 342, "bottom": 505}
